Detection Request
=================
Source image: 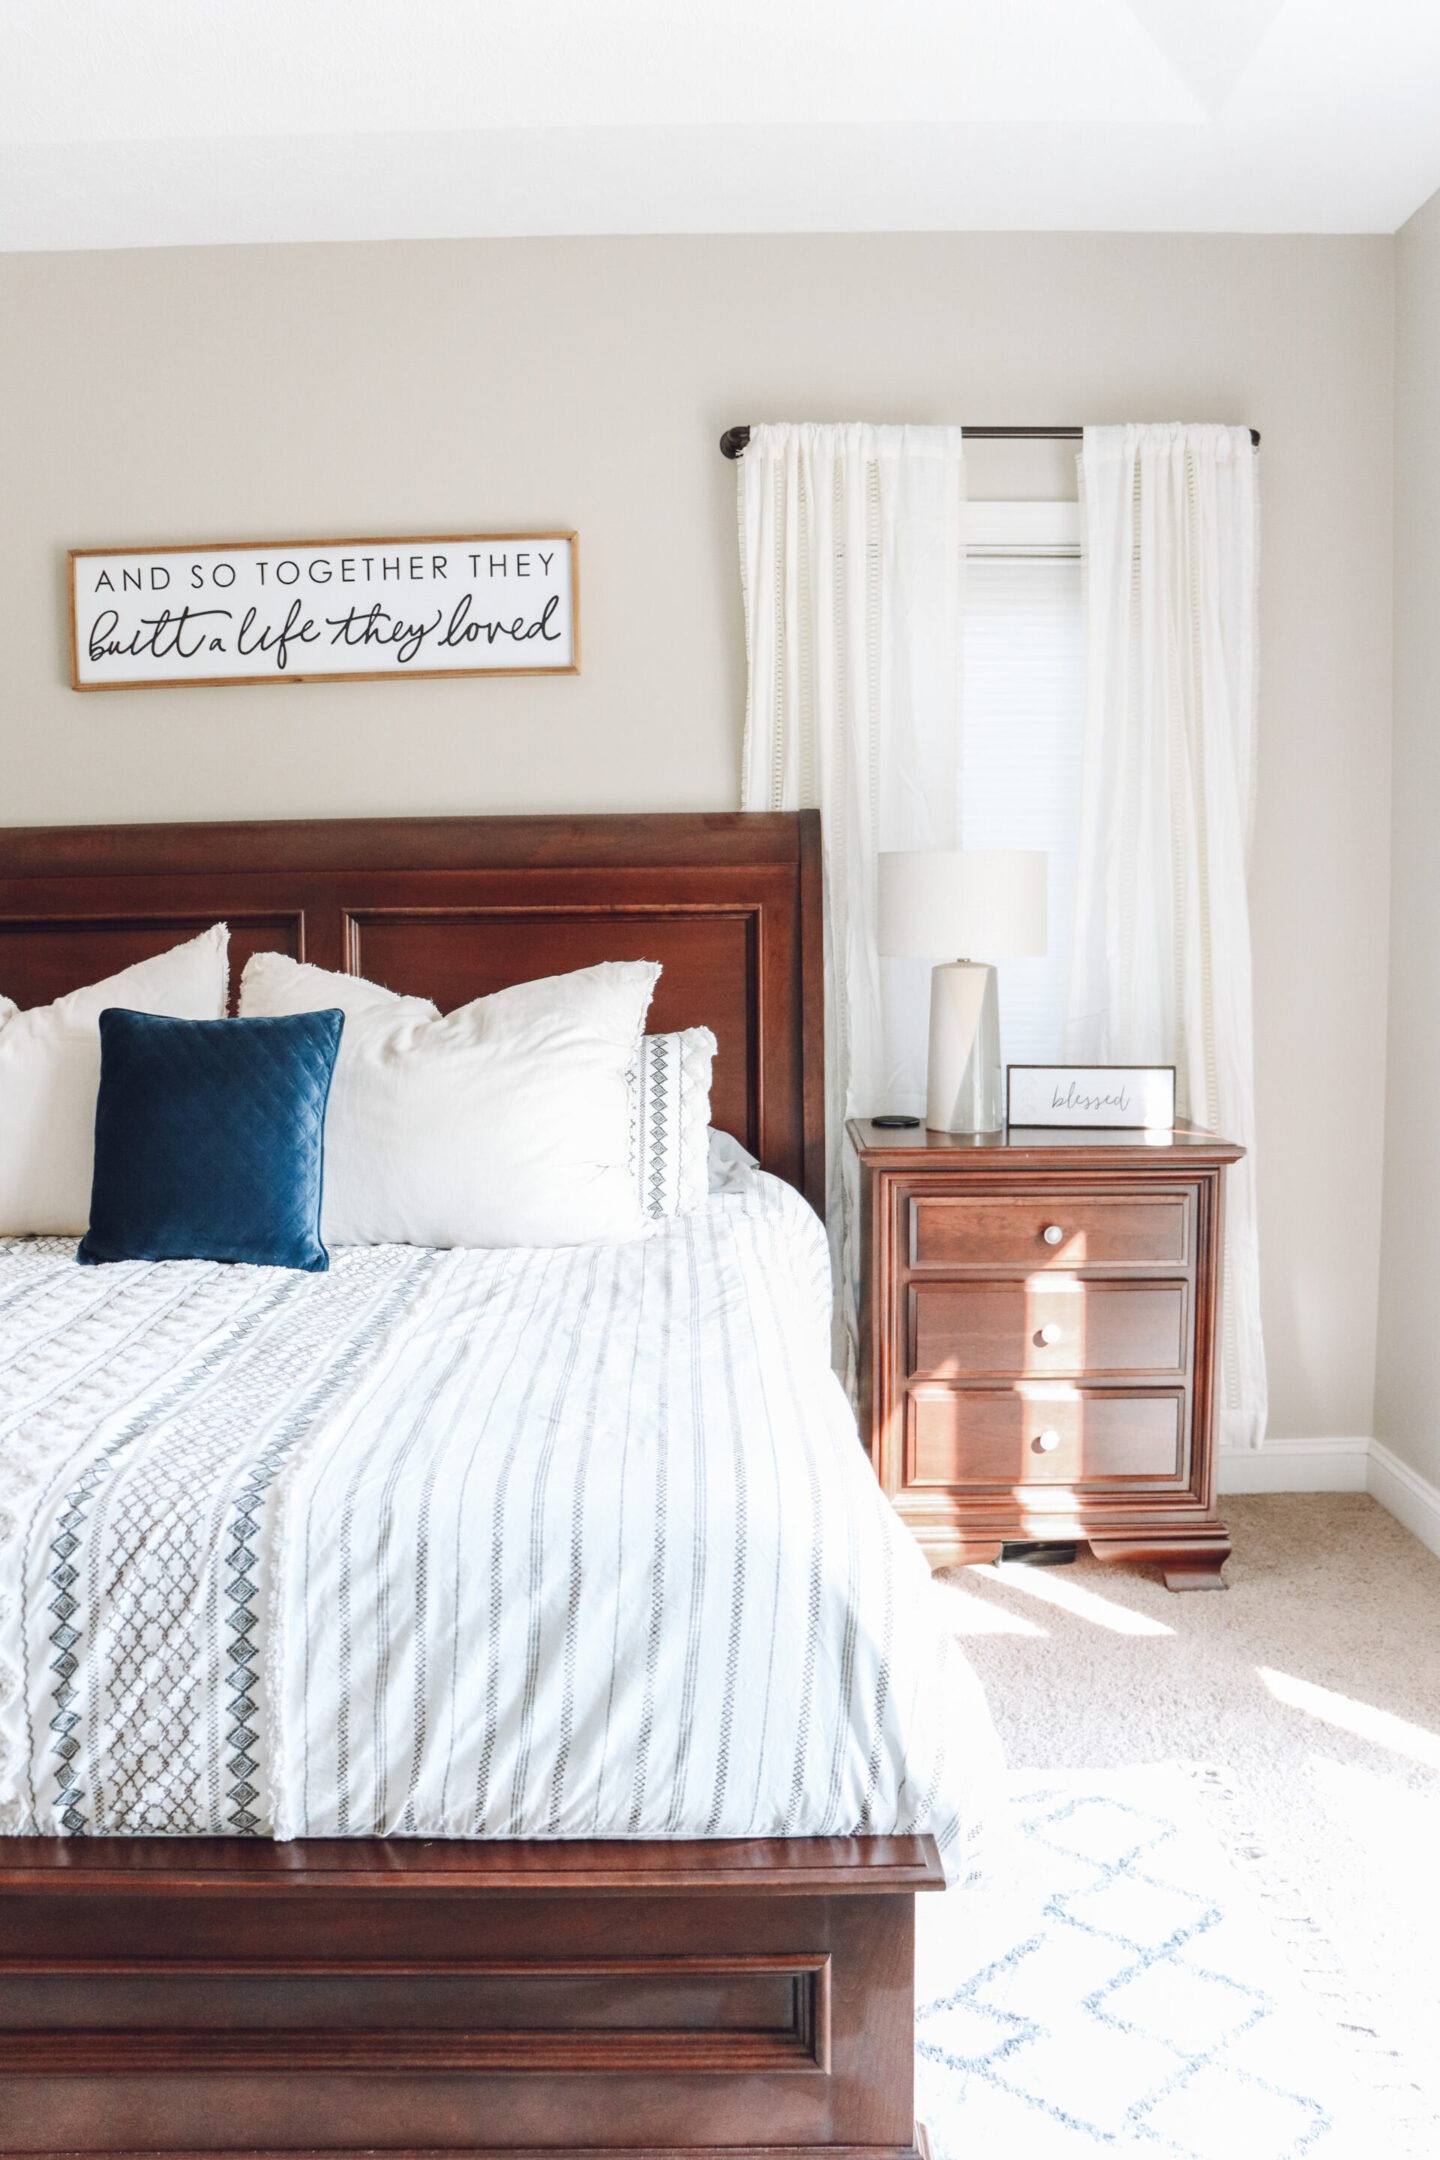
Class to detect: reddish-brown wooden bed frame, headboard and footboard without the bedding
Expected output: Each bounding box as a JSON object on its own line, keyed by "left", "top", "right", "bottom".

{"left": 0, "top": 812, "right": 941, "bottom": 2160}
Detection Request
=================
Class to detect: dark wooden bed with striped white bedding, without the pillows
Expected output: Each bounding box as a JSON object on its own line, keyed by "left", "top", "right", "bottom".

{"left": 0, "top": 812, "right": 980, "bottom": 2160}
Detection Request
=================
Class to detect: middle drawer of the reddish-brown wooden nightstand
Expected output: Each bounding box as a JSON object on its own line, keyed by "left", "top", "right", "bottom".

{"left": 909, "top": 1279, "right": 1190, "bottom": 1380}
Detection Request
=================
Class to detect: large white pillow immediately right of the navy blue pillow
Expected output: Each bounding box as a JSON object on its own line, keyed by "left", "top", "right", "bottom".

{"left": 240, "top": 953, "right": 661, "bottom": 1246}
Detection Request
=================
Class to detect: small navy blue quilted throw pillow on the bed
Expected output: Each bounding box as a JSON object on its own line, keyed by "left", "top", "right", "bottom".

{"left": 76, "top": 1007, "right": 345, "bottom": 1274}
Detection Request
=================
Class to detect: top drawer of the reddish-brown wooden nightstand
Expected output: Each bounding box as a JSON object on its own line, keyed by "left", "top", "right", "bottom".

{"left": 909, "top": 1192, "right": 1190, "bottom": 1268}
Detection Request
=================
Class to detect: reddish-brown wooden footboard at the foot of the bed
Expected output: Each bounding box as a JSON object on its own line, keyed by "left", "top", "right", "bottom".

{"left": 0, "top": 1838, "right": 941, "bottom": 2160}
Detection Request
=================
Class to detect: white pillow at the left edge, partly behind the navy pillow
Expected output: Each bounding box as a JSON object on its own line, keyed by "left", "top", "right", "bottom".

{"left": 0, "top": 922, "right": 231, "bottom": 1238}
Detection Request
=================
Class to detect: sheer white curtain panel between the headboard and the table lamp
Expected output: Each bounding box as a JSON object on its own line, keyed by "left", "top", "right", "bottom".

{"left": 738, "top": 426, "right": 965, "bottom": 1380}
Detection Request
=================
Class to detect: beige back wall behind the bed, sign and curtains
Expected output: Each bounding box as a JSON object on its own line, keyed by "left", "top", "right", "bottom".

{"left": 0, "top": 235, "right": 1393, "bottom": 1436}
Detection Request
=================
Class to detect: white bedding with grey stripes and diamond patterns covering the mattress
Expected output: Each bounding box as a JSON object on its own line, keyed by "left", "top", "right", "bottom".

{"left": 0, "top": 1173, "right": 993, "bottom": 1871}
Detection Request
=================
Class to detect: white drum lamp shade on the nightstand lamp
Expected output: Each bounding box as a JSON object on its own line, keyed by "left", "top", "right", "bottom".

{"left": 879, "top": 847, "right": 1045, "bottom": 961}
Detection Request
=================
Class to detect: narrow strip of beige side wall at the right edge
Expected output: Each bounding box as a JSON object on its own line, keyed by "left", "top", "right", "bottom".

{"left": 1375, "top": 194, "right": 1440, "bottom": 1482}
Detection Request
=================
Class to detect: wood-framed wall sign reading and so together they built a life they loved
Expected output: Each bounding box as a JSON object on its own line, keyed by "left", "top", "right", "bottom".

{"left": 69, "top": 534, "right": 581, "bottom": 689}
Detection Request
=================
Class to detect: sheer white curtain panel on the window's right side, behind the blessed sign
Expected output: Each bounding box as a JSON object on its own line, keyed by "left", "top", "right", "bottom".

{"left": 1067, "top": 426, "right": 1265, "bottom": 1447}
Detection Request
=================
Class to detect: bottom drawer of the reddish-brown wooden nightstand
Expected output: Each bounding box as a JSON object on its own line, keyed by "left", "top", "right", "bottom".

{"left": 905, "top": 1389, "right": 1185, "bottom": 1488}
